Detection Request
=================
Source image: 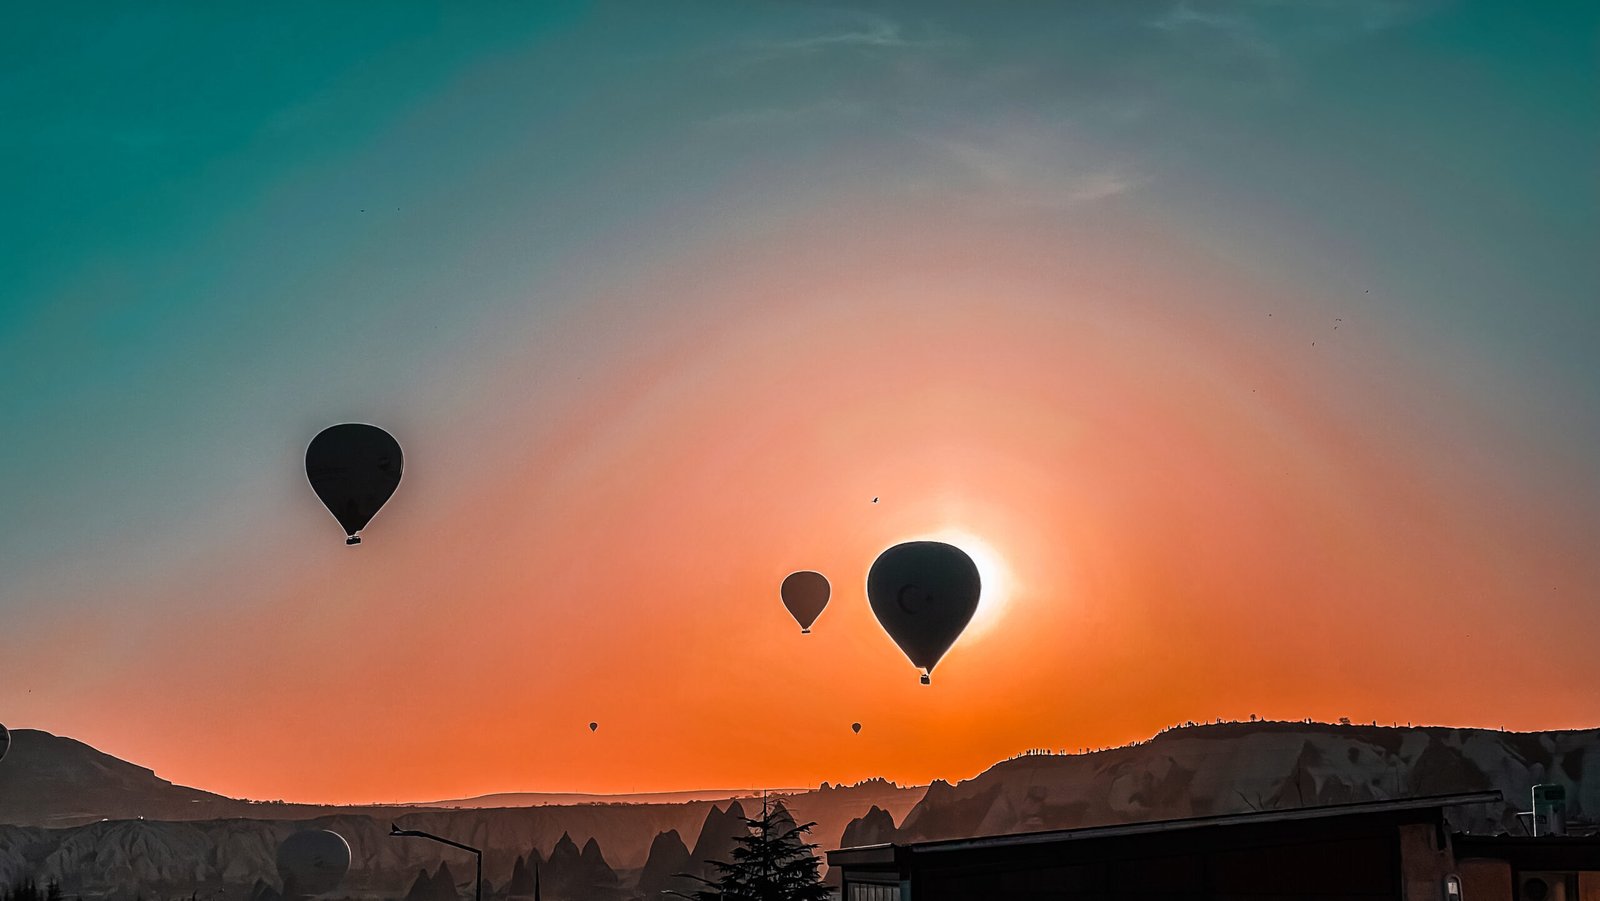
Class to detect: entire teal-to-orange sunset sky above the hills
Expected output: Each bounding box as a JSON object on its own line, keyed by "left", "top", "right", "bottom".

{"left": 0, "top": 0, "right": 1600, "bottom": 802}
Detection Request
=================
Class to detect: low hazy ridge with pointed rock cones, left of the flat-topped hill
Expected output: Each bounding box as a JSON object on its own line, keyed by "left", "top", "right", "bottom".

{"left": 0, "top": 730, "right": 922, "bottom": 901}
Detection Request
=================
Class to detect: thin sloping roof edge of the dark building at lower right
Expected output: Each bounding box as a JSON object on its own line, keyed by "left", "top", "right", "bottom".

{"left": 827, "top": 791, "right": 1504, "bottom": 866}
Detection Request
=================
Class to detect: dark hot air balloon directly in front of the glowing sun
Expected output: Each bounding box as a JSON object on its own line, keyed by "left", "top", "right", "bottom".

{"left": 867, "top": 541, "right": 982, "bottom": 685}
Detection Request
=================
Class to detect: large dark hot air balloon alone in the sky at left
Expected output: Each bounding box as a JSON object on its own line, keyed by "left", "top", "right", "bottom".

{"left": 306, "top": 422, "right": 402, "bottom": 544}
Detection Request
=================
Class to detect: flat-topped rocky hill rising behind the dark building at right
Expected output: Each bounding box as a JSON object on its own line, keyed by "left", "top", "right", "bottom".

{"left": 850, "top": 722, "right": 1600, "bottom": 842}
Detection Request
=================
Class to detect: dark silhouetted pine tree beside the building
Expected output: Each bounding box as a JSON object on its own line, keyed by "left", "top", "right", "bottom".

{"left": 669, "top": 800, "right": 829, "bottom": 901}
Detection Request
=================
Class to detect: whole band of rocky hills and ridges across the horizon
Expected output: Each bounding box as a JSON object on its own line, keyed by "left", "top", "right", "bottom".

{"left": 0, "top": 722, "right": 1600, "bottom": 901}
